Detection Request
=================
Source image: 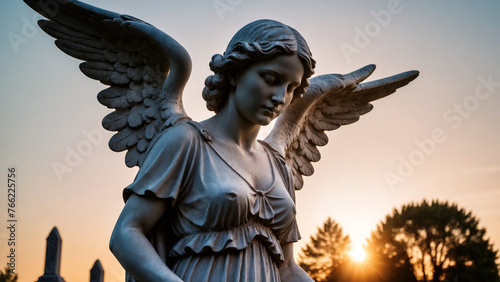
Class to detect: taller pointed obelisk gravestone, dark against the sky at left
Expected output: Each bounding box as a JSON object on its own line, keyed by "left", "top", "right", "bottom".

{"left": 38, "top": 227, "right": 65, "bottom": 282}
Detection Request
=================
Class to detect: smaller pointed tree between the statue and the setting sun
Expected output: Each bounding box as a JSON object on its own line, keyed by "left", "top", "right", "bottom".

{"left": 299, "top": 218, "right": 351, "bottom": 282}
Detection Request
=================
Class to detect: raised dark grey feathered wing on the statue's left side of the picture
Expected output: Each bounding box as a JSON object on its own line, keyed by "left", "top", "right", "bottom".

{"left": 24, "top": 0, "right": 191, "bottom": 167}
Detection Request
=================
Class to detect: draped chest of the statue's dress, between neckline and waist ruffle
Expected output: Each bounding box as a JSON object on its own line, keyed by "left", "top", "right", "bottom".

{"left": 181, "top": 149, "right": 294, "bottom": 230}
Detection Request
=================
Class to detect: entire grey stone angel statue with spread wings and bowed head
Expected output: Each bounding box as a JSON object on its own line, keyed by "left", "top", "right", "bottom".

{"left": 24, "top": 0, "right": 418, "bottom": 281}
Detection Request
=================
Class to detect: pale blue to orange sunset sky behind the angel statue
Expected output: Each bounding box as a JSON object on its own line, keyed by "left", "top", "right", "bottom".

{"left": 0, "top": 0, "right": 500, "bottom": 282}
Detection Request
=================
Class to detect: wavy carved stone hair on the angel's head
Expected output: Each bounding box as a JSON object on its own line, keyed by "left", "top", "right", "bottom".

{"left": 203, "top": 20, "right": 316, "bottom": 112}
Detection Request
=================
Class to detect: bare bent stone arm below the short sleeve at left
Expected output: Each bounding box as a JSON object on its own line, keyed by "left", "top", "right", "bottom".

{"left": 109, "top": 194, "right": 182, "bottom": 281}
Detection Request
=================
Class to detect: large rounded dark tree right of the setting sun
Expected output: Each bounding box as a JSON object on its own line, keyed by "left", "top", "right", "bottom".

{"left": 367, "top": 200, "right": 500, "bottom": 282}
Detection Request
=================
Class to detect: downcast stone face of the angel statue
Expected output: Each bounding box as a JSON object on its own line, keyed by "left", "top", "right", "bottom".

{"left": 233, "top": 55, "right": 304, "bottom": 125}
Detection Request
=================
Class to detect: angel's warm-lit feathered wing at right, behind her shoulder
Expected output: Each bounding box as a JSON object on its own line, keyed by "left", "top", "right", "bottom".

{"left": 265, "top": 65, "right": 419, "bottom": 190}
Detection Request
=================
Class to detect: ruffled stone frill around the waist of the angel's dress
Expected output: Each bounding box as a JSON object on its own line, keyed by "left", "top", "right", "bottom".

{"left": 168, "top": 223, "right": 284, "bottom": 265}
